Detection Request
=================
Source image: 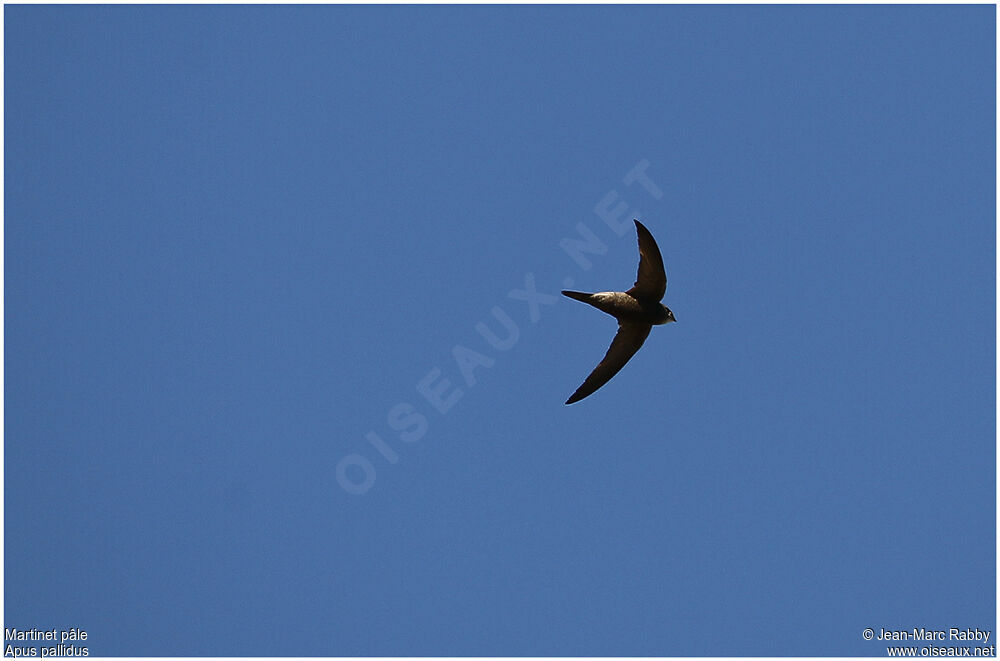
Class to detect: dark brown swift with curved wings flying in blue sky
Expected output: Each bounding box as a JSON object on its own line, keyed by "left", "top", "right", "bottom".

{"left": 563, "top": 220, "right": 677, "bottom": 404}
